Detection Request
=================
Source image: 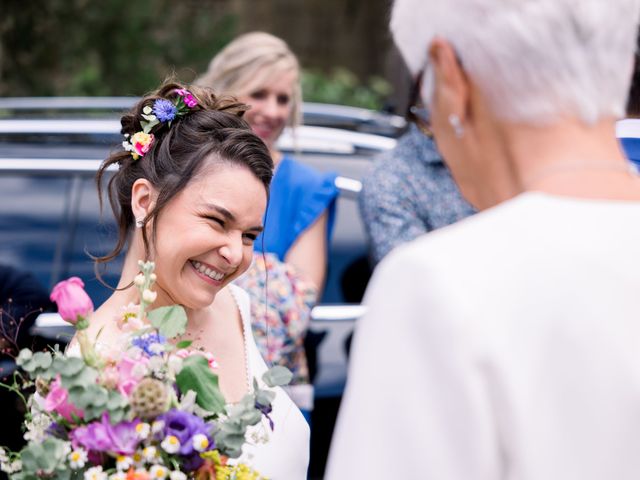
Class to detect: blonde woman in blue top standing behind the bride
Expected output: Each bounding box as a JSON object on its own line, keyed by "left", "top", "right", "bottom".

{"left": 196, "top": 32, "right": 338, "bottom": 418}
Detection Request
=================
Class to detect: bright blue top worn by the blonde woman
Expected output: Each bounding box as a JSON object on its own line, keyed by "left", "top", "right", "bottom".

{"left": 254, "top": 155, "right": 338, "bottom": 261}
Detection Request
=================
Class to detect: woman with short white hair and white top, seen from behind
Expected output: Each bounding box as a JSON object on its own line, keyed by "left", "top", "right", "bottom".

{"left": 327, "top": 0, "right": 640, "bottom": 480}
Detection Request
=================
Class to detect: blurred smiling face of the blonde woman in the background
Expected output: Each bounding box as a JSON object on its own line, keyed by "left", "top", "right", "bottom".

{"left": 239, "top": 71, "right": 298, "bottom": 150}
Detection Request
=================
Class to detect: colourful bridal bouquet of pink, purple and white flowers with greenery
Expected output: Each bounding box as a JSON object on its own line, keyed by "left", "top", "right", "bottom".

{"left": 0, "top": 262, "right": 291, "bottom": 480}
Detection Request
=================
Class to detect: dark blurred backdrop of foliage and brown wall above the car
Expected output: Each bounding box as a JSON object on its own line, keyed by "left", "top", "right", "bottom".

{"left": 0, "top": 0, "right": 407, "bottom": 111}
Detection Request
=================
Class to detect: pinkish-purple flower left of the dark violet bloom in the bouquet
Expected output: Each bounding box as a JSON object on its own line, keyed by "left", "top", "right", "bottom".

{"left": 70, "top": 412, "right": 140, "bottom": 455}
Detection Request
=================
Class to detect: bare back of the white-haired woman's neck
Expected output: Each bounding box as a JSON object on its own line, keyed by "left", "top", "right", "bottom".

{"left": 479, "top": 119, "right": 640, "bottom": 208}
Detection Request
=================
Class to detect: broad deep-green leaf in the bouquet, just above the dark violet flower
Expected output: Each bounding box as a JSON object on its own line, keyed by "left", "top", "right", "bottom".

{"left": 176, "top": 355, "right": 225, "bottom": 413}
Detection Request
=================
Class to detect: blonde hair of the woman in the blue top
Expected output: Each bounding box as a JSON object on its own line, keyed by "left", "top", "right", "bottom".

{"left": 195, "top": 32, "right": 302, "bottom": 126}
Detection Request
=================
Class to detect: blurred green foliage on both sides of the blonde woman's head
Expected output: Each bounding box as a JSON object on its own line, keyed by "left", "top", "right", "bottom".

{"left": 0, "top": 0, "right": 390, "bottom": 109}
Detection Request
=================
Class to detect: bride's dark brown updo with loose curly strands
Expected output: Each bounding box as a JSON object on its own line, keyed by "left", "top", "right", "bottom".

{"left": 93, "top": 82, "right": 273, "bottom": 275}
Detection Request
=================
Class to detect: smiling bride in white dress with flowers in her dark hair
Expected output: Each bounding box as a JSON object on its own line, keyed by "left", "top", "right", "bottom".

{"left": 80, "top": 80, "right": 309, "bottom": 480}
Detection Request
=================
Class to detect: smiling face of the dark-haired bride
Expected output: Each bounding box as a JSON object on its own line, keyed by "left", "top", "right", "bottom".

{"left": 153, "top": 164, "right": 267, "bottom": 309}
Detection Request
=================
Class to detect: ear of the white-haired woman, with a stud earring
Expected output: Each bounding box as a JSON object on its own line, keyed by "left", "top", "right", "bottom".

{"left": 429, "top": 37, "right": 470, "bottom": 122}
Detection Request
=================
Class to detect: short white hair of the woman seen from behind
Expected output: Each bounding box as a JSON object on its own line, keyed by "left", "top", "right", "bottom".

{"left": 391, "top": 0, "right": 640, "bottom": 124}
